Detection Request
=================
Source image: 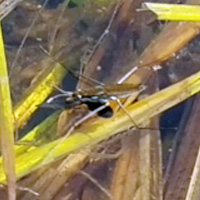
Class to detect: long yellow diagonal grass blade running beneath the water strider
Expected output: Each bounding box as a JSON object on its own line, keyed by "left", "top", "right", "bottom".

{"left": 0, "top": 67, "right": 200, "bottom": 183}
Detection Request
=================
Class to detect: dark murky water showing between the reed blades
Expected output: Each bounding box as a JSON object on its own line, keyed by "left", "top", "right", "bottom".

{"left": 3, "top": 0, "right": 200, "bottom": 199}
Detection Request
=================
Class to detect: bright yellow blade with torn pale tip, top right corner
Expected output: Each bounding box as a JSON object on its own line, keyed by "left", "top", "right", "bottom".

{"left": 142, "top": 2, "right": 200, "bottom": 21}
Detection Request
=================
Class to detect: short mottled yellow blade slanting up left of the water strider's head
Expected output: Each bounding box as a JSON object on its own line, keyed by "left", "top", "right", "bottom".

{"left": 14, "top": 63, "right": 66, "bottom": 129}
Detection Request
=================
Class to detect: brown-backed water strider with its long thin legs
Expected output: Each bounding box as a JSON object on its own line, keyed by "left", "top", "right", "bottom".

{"left": 40, "top": 46, "right": 146, "bottom": 120}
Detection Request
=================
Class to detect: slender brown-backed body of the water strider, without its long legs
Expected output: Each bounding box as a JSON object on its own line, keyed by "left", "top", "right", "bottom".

{"left": 47, "top": 84, "right": 145, "bottom": 108}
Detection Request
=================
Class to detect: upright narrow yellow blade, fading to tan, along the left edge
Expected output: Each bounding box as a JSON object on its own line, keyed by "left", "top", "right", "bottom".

{"left": 0, "top": 24, "right": 16, "bottom": 200}
